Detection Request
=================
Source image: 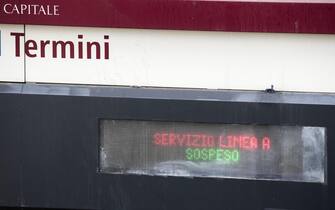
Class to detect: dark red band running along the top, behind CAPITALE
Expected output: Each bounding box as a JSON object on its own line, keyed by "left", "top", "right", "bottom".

{"left": 0, "top": 0, "right": 335, "bottom": 34}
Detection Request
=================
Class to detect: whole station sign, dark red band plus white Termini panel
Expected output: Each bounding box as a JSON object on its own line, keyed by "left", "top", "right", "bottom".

{"left": 0, "top": 0, "right": 335, "bottom": 92}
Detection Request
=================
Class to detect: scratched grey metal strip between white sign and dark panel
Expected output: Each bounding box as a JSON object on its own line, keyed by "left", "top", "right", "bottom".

{"left": 0, "top": 83, "right": 335, "bottom": 105}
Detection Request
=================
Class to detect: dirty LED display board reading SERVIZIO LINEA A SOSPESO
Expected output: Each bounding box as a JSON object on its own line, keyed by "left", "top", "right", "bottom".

{"left": 100, "top": 120, "right": 326, "bottom": 183}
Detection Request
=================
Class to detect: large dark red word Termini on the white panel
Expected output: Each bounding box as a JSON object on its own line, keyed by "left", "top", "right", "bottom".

{"left": 10, "top": 32, "right": 109, "bottom": 59}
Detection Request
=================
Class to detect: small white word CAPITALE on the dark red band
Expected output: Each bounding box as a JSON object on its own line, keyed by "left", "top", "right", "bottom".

{"left": 3, "top": 4, "right": 59, "bottom": 16}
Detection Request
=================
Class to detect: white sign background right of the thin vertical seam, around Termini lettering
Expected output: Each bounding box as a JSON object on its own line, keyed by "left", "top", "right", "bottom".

{"left": 1, "top": 25, "right": 335, "bottom": 92}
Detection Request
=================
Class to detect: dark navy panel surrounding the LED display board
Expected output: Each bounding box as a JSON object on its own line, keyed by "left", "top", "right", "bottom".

{"left": 0, "top": 84, "right": 335, "bottom": 210}
